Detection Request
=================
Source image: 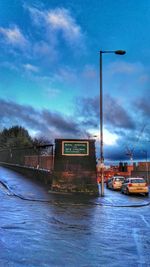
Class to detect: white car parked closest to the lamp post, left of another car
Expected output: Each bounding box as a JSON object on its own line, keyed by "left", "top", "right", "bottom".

{"left": 106, "top": 176, "right": 125, "bottom": 190}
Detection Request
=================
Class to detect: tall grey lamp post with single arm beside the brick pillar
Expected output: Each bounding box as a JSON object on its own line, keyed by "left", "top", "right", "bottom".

{"left": 100, "top": 50, "right": 126, "bottom": 196}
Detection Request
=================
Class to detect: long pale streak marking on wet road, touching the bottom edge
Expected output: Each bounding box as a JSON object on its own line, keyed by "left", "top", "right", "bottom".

{"left": 133, "top": 228, "right": 145, "bottom": 267}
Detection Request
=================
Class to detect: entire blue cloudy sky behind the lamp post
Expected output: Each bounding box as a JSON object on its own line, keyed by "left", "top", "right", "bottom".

{"left": 0, "top": 0, "right": 150, "bottom": 163}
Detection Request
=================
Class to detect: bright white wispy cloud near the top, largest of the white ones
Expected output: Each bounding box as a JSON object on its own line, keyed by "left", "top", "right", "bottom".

{"left": 25, "top": 6, "right": 84, "bottom": 46}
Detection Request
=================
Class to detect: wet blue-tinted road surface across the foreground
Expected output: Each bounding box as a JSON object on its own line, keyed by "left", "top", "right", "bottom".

{"left": 0, "top": 167, "right": 150, "bottom": 267}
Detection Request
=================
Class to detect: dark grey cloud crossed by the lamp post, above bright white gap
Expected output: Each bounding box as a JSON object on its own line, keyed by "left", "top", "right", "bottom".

{"left": 76, "top": 95, "right": 135, "bottom": 129}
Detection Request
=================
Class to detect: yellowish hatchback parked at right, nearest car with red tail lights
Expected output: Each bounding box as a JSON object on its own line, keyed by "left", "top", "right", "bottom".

{"left": 121, "top": 177, "right": 149, "bottom": 196}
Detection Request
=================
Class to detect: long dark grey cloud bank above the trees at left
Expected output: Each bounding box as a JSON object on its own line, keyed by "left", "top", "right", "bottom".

{"left": 0, "top": 99, "right": 86, "bottom": 139}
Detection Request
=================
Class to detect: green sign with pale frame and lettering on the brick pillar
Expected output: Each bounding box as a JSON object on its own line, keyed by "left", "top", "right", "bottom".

{"left": 62, "top": 141, "right": 89, "bottom": 156}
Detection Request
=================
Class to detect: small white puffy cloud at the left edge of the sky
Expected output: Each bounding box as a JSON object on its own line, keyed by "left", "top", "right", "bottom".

{"left": 0, "top": 25, "right": 28, "bottom": 48}
